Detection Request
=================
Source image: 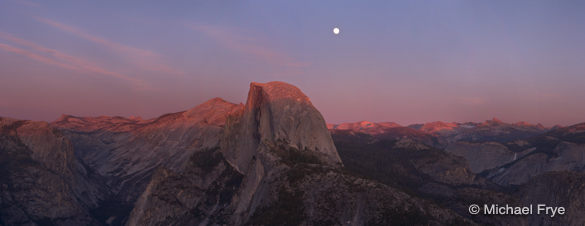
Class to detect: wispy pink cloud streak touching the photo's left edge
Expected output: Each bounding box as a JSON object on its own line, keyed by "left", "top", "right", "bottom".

{"left": 0, "top": 32, "right": 146, "bottom": 88}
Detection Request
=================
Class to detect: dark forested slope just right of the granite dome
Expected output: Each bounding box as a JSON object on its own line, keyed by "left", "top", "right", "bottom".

{"left": 333, "top": 131, "right": 484, "bottom": 192}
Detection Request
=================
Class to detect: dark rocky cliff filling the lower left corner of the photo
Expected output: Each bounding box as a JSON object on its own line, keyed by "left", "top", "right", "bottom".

{"left": 0, "top": 118, "right": 103, "bottom": 225}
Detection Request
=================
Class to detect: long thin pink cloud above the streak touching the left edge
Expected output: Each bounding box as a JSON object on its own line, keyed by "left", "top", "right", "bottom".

{"left": 35, "top": 17, "right": 184, "bottom": 75}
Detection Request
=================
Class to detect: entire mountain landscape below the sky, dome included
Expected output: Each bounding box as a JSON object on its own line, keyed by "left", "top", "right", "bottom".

{"left": 0, "top": 82, "right": 585, "bottom": 225}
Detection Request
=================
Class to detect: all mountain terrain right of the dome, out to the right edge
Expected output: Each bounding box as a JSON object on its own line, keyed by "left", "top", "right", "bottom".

{"left": 329, "top": 120, "right": 585, "bottom": 225}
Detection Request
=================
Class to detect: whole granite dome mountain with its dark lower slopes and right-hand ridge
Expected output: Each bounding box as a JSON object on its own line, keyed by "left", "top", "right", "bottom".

{"left": 128, "top": 82, "right": 465, "bottom": 225}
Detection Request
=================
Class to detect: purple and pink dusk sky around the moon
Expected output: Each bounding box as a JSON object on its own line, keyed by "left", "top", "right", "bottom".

{"left": 0, "top": 0, "right": 585, "bottom": 126}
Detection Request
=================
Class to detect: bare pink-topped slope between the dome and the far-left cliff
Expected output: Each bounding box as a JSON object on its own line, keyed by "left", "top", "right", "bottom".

{"left": 51, "top": 98, "right": 242, "bottom": 224}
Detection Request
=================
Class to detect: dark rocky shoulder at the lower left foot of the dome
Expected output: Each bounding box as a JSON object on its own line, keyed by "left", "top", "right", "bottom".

{"left": 127, "top": 150, "right": 243, "bottom": 225}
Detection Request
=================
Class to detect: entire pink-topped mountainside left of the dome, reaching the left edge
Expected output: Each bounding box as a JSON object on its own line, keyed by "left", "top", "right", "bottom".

{"left": 0, "top": 98, "right": 242, "bottom": 225}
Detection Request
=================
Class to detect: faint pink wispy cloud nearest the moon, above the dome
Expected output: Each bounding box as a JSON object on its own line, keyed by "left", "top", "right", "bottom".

{"left": 188, "top": 24, "right": 308, "bottom": 67}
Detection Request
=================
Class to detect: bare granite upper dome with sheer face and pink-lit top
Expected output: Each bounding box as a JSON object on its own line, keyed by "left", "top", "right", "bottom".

{"left": 225, "top": 82, "right": 342, "bottom": 171}
